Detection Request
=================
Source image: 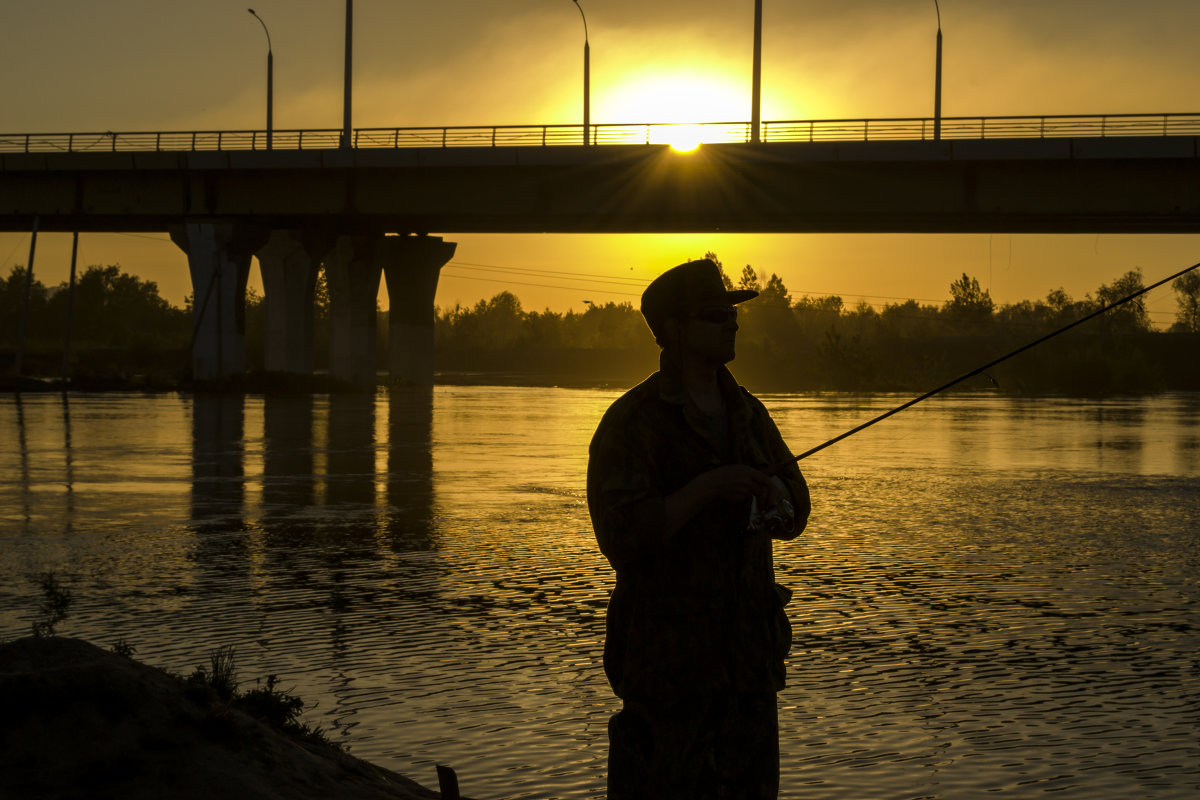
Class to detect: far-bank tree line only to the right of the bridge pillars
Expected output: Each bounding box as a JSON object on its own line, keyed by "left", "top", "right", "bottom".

{"left": 436, "top": 253, "right": 1200, "bottom": 393}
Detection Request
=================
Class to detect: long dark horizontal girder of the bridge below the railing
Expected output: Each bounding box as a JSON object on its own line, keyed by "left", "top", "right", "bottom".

{"left": 0, "top": 137, "right": 1200, "bottom": 234}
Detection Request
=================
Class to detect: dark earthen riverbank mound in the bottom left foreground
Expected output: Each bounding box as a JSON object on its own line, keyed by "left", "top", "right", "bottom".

{"left": 0, "top": 637, "right": 468, "bottom": 800}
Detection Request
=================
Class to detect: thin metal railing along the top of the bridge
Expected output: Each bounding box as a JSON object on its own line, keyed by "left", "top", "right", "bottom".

{"left": 0, "top": 113, "right": 1200, "bottom": 152}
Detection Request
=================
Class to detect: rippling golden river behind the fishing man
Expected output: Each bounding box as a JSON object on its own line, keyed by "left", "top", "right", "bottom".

{"left": 0, "top": 386, "right": 1200, "bottom": 800}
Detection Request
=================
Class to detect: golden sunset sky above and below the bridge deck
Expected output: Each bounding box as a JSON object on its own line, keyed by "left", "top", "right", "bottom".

{"left": 0, "top": 0, "right": 1200, "bottom": 321}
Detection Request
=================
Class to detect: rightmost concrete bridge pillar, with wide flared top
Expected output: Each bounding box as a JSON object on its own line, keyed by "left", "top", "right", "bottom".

{"left": 383, "top": 236, "right": 458, "bottom": 385}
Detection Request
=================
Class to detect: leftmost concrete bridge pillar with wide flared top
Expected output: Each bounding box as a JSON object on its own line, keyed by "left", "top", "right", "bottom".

{"left": 170, "top": 222, "right": 266, "bottom": 381}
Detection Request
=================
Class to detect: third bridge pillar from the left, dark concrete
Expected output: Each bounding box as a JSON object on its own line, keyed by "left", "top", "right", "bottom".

{"left": 325, "top": 235, "right": 388, "bottom": 386}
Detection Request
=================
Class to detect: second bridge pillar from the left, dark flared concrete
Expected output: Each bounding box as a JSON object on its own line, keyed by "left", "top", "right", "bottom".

{"left": 256, "top": 230, "right": 331, "bottom": 375}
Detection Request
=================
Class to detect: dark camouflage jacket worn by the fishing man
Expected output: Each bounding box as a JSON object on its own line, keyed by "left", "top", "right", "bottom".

{"left": 588, "top": 359, "right": 809, "bottom": 699}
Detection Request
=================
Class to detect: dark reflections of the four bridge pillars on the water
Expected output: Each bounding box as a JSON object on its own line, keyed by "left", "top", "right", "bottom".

{"left": 184, "top": 387, "right": 433, "bottom": 561}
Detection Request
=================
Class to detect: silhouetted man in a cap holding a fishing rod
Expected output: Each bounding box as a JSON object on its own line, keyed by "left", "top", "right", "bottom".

{"left": 588, "top": 259, "right": 810, "bottom": 800}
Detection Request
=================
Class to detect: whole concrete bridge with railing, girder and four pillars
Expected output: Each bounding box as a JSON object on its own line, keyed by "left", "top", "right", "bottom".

{"left": 0, "top": 114, "right": 1200, "bottom": 383}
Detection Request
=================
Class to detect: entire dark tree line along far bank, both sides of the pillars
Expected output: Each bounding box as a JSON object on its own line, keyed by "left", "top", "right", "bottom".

{"left": 0, "top": 253, "right": 1200, "bottom": 393}
